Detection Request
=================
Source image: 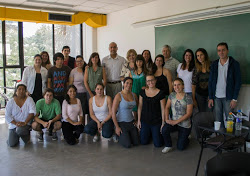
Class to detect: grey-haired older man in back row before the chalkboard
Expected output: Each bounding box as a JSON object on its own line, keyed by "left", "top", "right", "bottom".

{"left": 162, "top": 45, "right": 180, "bottom": 81}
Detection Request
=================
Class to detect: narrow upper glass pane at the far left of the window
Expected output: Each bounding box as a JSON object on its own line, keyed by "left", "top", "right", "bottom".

{"left": 5, "top": 21, "right": 19, "bottom": 65}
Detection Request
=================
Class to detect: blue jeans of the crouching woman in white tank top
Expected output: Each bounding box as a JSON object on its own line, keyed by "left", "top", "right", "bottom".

{"left": 84, "top": 119, "right": 114, "bottom": 138}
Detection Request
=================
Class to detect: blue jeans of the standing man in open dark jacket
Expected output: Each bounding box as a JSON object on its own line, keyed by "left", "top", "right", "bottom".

{"left": 214, "top": 98, "right": 233, "bottom": 128}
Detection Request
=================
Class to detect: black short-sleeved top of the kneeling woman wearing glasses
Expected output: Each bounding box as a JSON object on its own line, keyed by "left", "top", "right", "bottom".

{"left": 140, "top": 89, "right": 165, "bottom": 125}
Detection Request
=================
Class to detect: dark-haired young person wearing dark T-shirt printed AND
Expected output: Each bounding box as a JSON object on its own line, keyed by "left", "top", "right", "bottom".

{"left": 47, "top": 53, "right": 71, "bottom": 105}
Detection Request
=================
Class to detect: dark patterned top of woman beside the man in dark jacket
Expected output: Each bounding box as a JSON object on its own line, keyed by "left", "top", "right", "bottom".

{"left": 192, "top": 69, "right": 209, "bottom": 96}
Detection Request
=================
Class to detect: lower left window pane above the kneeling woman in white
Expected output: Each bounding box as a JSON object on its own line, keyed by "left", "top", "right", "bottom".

{"left": 5, "top": 68, "right": 21, "bottom": 97}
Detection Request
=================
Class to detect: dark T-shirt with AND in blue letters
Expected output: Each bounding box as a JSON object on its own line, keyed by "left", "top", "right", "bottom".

{"left": 48, "top": 66, "right": 71, "bottom": 96}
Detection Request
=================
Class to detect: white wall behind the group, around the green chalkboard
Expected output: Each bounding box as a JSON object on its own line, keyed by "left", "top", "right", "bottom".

{"left": 97, "top": 0, "right": 250, "bottom": 115}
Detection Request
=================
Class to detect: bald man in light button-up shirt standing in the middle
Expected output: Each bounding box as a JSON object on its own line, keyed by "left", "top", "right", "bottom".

{"left": 102, "top": 42, "right": 126, "bottom": 99}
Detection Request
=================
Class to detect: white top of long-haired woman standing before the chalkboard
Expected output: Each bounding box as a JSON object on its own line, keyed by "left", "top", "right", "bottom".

{"left": 177, "top": 63, "right": 193, "bottom": 93}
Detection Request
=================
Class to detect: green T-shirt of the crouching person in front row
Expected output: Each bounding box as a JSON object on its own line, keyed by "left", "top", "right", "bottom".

{"left": 36, "top": 98, "right": 62, "bottom": 120}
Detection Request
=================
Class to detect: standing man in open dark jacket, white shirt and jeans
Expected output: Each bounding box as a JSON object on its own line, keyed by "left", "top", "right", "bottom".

{"left": 208, "top": 42, "right": 241, "bottom": 127}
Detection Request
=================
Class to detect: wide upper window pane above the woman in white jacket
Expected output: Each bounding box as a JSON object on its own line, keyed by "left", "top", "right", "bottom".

{"left": 23, "top": 22, "right": 53, "bottom": 66}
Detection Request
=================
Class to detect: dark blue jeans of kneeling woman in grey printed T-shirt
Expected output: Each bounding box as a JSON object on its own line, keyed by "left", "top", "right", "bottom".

{"left": 162, "top": 123, "right": 192, "bottom": 150}
